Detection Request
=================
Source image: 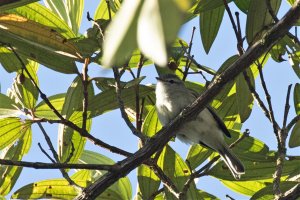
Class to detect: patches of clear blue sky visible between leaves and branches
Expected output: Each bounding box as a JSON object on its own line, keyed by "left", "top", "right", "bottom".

{"left": 0, "top": 1, "right": 300, "bottom": 199}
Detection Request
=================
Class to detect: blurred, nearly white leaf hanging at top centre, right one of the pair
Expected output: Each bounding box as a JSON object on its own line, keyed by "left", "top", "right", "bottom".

{"left": 137, "top": 0, "right": 189, "bottom": 66}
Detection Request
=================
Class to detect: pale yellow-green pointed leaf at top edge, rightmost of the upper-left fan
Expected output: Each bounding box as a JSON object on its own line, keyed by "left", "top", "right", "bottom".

{"left": 66, "top": 0, "right": 84, "bottom": 34}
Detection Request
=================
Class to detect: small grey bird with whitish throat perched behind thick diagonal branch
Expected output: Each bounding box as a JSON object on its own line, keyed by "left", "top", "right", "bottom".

{"left": 155, "top": 74, "right": 245, "bottom": 179}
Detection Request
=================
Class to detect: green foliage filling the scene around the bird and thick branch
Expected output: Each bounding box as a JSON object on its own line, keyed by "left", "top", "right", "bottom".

{"left": 0, "top": 0, "right": 300, "bottom": 199}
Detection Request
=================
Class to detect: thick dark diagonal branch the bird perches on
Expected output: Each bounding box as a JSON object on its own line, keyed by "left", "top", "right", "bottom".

{"left": 75, "top": 0, "right": 300, "bottom": 200}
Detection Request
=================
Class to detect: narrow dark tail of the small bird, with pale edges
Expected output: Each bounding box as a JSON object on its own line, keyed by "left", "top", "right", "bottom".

{"left": 218, "top": 146, "right": 245, "bottom": 179}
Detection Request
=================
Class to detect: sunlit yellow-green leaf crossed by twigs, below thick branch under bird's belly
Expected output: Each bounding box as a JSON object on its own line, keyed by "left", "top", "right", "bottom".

{"left": 157, "top": 145, "right": 200, "bottom": 199}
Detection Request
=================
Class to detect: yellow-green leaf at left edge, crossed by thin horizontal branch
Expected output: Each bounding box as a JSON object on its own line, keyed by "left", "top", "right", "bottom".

{"left": 0, "top": 127, "right": 32, "bottom": 195}
